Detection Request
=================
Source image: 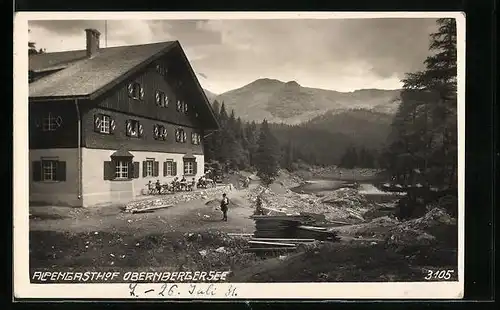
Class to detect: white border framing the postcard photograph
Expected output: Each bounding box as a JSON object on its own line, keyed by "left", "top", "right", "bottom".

{"left": 13, "top": 12, "right": 465, "bottom": 299}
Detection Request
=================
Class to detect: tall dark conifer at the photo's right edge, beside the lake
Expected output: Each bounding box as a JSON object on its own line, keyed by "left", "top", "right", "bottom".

{"left": 386, "top": 18, "right": 458, "bottom": 188}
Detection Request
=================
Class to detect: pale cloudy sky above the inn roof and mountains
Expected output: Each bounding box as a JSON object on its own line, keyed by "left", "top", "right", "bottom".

{"left": 29, "top": 18, "right": 436, "bottom": 93}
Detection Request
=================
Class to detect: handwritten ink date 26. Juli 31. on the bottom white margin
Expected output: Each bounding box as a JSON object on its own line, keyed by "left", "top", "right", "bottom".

{"left": 129, "top": 283, "right": 238, "bottom": 298}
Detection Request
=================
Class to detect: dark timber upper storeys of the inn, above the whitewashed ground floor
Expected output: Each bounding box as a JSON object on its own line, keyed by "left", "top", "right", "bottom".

{"left": 29, "top": 53, "right": 204, "bottom": 155}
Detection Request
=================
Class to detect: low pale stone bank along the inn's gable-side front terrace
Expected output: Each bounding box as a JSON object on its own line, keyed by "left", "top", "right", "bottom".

{"left": 125, "top": 184, "right": 234, "bottom": 212}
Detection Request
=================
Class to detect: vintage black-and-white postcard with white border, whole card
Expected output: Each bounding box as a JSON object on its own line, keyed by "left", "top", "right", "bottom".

{"left": 13, "top": 12, "right": 466, "bottom": 300}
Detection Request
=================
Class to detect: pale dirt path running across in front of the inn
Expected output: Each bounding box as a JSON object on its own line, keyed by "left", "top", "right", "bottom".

{"left": 30, "top": 185, "right": 255, "bottom": 236}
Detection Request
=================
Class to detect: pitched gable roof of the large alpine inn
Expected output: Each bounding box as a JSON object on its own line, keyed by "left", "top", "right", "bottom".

{"left": 29, "top": 41, "right": 220, "bottom": 129}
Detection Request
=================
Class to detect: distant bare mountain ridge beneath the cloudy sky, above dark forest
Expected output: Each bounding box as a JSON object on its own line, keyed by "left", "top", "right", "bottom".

{"left": 210, "top": 78, "right": 401, "bottom": 125}
